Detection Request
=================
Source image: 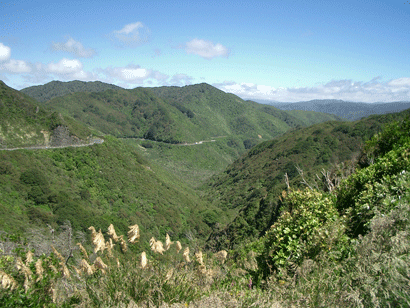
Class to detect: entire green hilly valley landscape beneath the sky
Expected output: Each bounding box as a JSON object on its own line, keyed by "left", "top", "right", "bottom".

{"left": 0, "top": 81, "right": 410, "bottom": 306}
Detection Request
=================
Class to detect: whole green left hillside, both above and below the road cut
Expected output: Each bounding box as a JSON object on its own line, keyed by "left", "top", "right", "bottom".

{"left": 0, "top": 83, "right": 219, "bottom": 245}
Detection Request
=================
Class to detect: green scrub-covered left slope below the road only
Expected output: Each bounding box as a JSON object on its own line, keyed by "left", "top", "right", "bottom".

{"left": 0, "top": 137, "right": 218, "bottom": 242}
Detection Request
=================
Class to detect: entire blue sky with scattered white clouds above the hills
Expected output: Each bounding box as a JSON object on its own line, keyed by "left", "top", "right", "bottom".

{"left": 0, "top": 0, "right": 410, "bottom": 102}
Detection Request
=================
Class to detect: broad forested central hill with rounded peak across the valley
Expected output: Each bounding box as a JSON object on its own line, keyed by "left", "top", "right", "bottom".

{"left": 23, "top": 84, "right": 337, "bottom": 145}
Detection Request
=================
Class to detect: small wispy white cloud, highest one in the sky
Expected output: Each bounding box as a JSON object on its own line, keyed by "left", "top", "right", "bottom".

{"left": 110, "top": 21, "right": 150, "bottom": 47}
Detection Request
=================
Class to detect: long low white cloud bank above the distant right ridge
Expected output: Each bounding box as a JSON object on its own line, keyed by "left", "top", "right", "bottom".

{"left": 214, "top": 77, "right": 410, "bottom": 103}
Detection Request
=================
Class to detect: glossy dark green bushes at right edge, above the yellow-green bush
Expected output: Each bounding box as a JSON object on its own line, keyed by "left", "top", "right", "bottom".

{"left": 337, "top": 120, "right": 410, "bottom": 237}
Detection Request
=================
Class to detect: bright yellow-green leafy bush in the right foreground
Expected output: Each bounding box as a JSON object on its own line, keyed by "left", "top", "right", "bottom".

{"left": 258, "top": 189, "right": 348, "bottom": 277}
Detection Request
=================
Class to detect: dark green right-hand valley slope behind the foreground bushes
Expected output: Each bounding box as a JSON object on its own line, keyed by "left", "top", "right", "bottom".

{"left": 208, "top": 110, "right": 410, "bottom": 248}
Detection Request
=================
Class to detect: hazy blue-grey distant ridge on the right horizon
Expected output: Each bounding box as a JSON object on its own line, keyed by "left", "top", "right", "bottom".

{"left": 256, "top": 99, "right": 410, "bottom": 121}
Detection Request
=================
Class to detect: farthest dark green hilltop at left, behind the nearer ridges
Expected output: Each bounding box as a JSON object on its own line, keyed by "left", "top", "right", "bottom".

{"left": 20, "top": 80, "right": 122, "bottom": 102}
